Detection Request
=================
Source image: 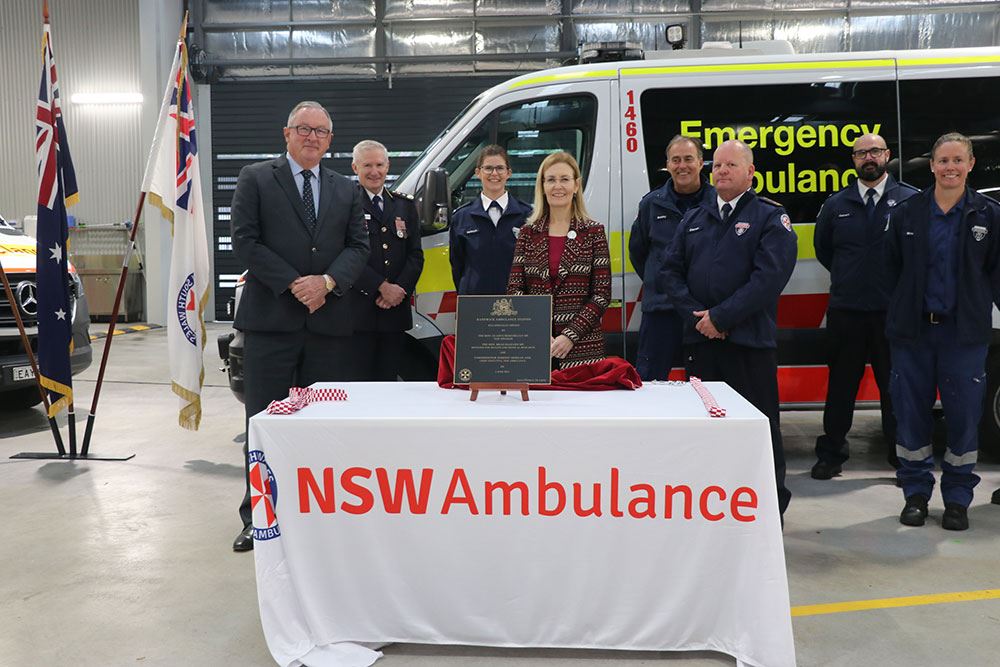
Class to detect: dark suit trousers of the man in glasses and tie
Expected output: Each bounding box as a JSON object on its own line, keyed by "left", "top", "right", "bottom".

{"left": 240, "top": 329, "right": 350, "bottom": 528}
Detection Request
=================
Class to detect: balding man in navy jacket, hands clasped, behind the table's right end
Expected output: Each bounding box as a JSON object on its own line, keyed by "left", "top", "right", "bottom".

{"left": 662, "top": 140, "right": 798, "bottom": 516}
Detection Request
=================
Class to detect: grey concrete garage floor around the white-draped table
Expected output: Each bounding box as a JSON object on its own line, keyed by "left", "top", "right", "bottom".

{"left": 0, "top": 324, "right": 1000, "bottom": 667}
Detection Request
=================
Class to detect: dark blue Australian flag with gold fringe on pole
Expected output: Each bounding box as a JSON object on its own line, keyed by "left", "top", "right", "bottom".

{"left": 35, "top": 18, "right": 79, "bottom": 417}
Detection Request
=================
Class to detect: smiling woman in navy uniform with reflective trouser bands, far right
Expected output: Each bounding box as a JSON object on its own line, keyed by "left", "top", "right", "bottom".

{"left": 886, "top": 133, "right": 1000, "bottom": 530}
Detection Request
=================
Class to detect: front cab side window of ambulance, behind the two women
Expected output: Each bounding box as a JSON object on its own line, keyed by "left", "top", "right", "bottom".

{"left": 443, "top": 95, "right": 597, "bottom": 207}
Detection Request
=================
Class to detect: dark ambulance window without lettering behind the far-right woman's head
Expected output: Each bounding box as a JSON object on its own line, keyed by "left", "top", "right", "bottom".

{"left": 899, "top": 78, "right": 1000, "bottom": 200}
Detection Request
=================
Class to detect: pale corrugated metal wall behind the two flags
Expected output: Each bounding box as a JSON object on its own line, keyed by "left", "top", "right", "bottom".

{"left": 0, "top": 0, "right": 141, "bottom": 223}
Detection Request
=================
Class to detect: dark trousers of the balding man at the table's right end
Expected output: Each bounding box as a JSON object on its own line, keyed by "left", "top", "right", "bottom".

{"left": 684, "top": 340, "right": 792, "bottom": 516}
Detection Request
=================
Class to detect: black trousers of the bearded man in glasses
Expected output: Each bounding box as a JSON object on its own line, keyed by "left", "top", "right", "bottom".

{"left": 816, "top": 308, "right": 899, "bottom": 467}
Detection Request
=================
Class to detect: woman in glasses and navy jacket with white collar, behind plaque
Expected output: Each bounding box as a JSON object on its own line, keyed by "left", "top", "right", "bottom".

{"left": 449, "top": 144, "right": 531, "bottom": 294}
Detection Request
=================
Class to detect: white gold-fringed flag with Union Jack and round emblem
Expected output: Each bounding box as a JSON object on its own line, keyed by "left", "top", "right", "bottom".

{"left": 142, "top": 37, "right": 211, "bottom": 430}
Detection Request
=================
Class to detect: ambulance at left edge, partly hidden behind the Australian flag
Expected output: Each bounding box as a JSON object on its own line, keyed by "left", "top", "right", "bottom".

{"left": 0, "top": 217, "right": 93, "bottom": 411}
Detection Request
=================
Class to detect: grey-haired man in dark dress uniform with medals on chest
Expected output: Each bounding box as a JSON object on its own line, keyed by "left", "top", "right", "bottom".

{"left": 351, "top": 139, "right": 424, "bottom": 382}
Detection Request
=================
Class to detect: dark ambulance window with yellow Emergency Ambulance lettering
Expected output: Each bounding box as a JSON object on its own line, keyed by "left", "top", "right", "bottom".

{"left": 640, "top": 81, "right": 899, "bottom": 222}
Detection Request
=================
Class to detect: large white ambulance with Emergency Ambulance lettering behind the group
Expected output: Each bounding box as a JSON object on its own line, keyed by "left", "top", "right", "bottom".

{"left": 395, "top": 48, "right": 1000, "bottom": 454}
